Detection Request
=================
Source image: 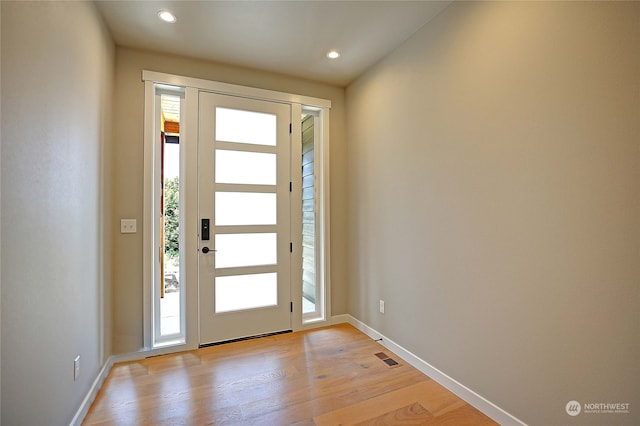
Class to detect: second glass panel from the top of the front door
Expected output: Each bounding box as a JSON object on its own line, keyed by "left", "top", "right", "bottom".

{"left": 215, "top": 149, "right": 276, "bottom": 185}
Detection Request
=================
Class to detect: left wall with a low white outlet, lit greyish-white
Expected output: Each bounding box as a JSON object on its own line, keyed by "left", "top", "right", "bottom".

{"left": 0, "top": 1, "right": 114, "bottom": 425}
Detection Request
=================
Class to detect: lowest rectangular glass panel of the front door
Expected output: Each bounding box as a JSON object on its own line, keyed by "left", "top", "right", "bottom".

{"left": 215, "top": 272, "right": 278, "bottom": 313}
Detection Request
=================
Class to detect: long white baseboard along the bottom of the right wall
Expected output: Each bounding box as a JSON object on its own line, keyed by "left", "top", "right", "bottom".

{"left": 348, "top": 315, "right": 526, "bottom": 426}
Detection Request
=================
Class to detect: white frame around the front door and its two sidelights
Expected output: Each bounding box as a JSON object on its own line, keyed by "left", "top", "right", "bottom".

{"left": 142, "top": 70, "right": 331, "bottom": 354}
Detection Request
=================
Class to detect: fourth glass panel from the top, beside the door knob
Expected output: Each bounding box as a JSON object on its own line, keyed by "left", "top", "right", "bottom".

{"left": 216, "top": 233, "right": 278, "bottom": 268}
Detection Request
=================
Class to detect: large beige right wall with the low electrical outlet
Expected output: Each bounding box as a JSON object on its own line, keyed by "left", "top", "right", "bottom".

{"left": 346, "top": 2, "right": 640, "bottom": 425}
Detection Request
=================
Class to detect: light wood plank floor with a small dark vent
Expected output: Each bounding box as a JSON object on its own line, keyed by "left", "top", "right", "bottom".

{"left": 83, "top": 324, "right": 496, "bottom": 426}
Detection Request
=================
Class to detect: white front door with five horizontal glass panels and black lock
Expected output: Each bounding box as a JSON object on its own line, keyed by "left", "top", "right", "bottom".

{"left": 198, "top": 92, "right": 291, "bottom": 344}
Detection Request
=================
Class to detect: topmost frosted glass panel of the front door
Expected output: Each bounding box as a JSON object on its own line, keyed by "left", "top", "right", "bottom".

{"left": 216, "top": 107, "right": 276, "bottom": 146}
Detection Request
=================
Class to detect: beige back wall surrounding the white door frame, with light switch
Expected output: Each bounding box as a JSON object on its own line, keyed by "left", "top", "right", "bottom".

{"left": 111, "top": 47, "right": 347, "bottom": 353}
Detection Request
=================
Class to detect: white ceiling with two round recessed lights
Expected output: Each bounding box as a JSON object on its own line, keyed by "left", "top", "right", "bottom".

{"left": 96, "top": 0, "right": 450, "bottom": 86}
